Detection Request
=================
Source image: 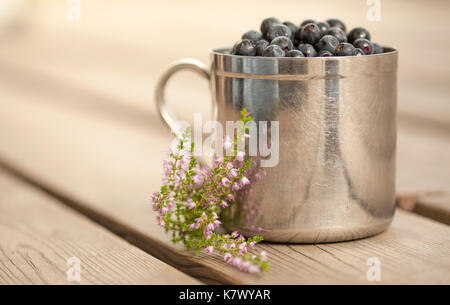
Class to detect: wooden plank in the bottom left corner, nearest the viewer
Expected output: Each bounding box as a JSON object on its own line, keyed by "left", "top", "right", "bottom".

{"left": 0, "top": 170, "right": 199, "bottom": 285}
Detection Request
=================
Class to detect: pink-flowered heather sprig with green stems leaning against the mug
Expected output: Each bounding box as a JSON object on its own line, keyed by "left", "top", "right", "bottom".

{"left": 152, "top": 109, "right": 268, "bottom": 273}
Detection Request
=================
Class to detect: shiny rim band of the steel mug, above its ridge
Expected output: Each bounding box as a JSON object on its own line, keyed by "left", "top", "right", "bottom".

{"left": 210, "top": 46, "right": 398, "bottom": 80}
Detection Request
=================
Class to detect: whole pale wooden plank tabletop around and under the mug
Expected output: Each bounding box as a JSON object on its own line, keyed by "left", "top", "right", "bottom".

{"left": 0, "top": 0, "right": 450, "bottom": 284}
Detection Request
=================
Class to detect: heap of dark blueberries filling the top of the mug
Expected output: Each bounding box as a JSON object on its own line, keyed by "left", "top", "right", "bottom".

{"left": 231, "top": 17, "right": 383, "bottom": 57}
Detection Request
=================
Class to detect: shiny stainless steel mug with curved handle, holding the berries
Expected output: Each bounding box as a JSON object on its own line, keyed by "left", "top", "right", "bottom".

{"left": 156, "top": 48, "right": 398, "bottom": 243}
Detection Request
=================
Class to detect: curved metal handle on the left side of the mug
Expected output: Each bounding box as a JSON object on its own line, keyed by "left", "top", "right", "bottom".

{"left": 155, "top": 59, "right": 217, "bottom": 138}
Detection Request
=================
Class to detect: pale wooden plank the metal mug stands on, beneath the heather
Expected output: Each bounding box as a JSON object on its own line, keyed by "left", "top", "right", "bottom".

{"left": 0, "top": 83, "right": 450, "bottom": 284}
